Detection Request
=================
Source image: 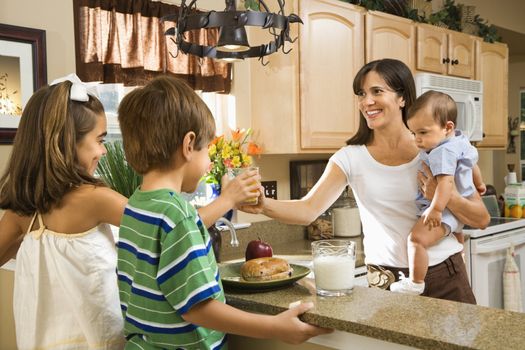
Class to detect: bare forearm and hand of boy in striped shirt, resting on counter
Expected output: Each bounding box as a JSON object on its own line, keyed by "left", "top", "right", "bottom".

{"left": 182, "top": 299, "right": 332, "bottom": 344}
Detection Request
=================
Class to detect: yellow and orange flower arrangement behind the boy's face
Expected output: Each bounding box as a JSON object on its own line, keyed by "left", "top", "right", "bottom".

{"left": 204, "top": 128, "right": 262, "bottom": 187}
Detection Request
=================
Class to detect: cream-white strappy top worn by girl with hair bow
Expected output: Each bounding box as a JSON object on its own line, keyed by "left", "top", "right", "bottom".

{"left": 13, "top": 215, "right": 125, "bottom": 350}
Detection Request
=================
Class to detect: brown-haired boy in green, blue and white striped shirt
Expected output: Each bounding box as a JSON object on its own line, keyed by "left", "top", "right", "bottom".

{"left": 117, "top": 77, "right": 329, "bottom": 349}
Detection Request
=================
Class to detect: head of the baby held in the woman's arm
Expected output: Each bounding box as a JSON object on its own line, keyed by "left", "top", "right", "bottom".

{"left": 407, "top": 90, "right": 457, "bottom": 151}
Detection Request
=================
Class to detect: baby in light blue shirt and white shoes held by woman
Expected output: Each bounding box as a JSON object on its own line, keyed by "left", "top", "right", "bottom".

{"left": 390, "top": 90, "right": 486, "bottom": 295}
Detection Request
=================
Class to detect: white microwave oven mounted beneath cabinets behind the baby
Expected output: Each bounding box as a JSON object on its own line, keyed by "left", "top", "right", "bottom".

{"left": 415, "top": 73, "right": 483, "bottom": 142}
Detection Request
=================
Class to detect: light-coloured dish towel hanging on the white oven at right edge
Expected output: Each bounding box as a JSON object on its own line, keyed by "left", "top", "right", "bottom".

{"left": 503, "top": 244, "right": 523, "bottom": 312}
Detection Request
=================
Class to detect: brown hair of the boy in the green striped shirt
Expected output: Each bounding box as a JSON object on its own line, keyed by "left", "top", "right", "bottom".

{"left": 118, "top": 76, "right": 215, "bottom": 175}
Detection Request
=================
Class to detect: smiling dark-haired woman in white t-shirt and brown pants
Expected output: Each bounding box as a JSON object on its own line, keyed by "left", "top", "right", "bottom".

{"left": 243, "top": 59, "right": 490, "bottom": 303}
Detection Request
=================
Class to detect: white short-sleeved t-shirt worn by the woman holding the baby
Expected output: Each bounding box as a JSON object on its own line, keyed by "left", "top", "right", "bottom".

{"left": 330, "top": 146, "right": 463, "bottom": 267}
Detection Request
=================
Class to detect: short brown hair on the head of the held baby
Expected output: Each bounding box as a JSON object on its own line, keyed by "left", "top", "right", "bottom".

{"left": 407, "top": 90, "right": 458, "bottom": 127}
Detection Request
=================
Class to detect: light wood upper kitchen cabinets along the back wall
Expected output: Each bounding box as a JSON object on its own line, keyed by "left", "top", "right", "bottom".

{"left": 243, "top": 0, "right": 508, "bottom": 154}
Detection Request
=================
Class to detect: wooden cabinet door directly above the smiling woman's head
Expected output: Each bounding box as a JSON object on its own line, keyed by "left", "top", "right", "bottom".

{"left": 365, "top": 11, "right": 416, "bottom": 72}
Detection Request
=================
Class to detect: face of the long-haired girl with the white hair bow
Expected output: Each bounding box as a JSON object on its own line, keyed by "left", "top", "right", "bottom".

{"left": 76, "top": 115, "right": 107, "bottom": 175}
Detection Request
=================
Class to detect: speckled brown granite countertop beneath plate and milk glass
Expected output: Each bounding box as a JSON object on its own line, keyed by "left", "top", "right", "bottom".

{"left": 221, "top": 221, "right": 525, "bottom": 350}
